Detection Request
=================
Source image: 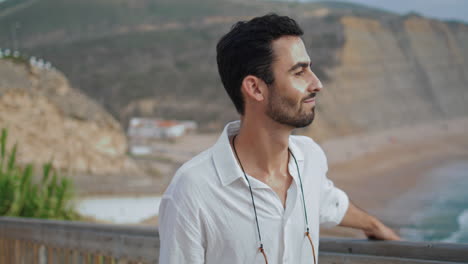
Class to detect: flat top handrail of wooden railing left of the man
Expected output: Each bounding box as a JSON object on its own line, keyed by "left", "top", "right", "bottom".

{"left": 0, "top": 217, "right": 159, "bottom": 263}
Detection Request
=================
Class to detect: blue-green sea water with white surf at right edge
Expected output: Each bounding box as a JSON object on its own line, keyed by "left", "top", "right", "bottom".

{"left": 400, "top": 161, "right": 468, "bottom": 243}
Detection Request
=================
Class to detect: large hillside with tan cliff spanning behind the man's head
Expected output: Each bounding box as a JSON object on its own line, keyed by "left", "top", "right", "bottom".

{"left": 0, "top": 0, "right": 468, "bottom": 139}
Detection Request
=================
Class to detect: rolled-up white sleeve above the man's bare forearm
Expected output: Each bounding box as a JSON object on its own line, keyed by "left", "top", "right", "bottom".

{"left": 320, "top": 176, "right": 349, "bottom": 227}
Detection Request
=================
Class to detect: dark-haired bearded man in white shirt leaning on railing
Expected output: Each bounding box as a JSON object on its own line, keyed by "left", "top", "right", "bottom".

{"left": 159, "top": 14, "right": 399, "bottom": 264}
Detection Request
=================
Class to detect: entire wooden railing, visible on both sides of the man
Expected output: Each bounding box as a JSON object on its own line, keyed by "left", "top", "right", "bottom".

{"left": 0, "top": 217, "right": 468, "bottom": 264}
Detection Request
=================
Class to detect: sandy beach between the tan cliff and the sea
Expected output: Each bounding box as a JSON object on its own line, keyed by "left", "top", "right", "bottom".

{"left": 321, "top": 119, "right": 468, "bottom": 238}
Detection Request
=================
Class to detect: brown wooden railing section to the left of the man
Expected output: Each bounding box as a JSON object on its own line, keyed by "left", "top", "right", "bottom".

{"left": 0, "top": 217, "right": 159, "bottom": 264}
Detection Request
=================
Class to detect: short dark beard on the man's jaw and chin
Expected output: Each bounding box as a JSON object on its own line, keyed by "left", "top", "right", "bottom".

{"left": 266, "top": 85, "right": 315, "bottom": 128}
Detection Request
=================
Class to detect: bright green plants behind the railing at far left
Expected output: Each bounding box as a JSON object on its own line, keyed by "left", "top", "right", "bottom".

{"left": 0, "top": 129, "right": 78, "bottom": 220}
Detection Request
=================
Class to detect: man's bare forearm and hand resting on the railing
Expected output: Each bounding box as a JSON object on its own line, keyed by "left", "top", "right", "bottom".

{"left": 339, "top": 201, "right": 401, "bottom": 240}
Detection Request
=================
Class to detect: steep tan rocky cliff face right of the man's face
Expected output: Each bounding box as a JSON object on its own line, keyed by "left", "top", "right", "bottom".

{"left": 305, "top": 16, "right": 468, "bottom": 138}
